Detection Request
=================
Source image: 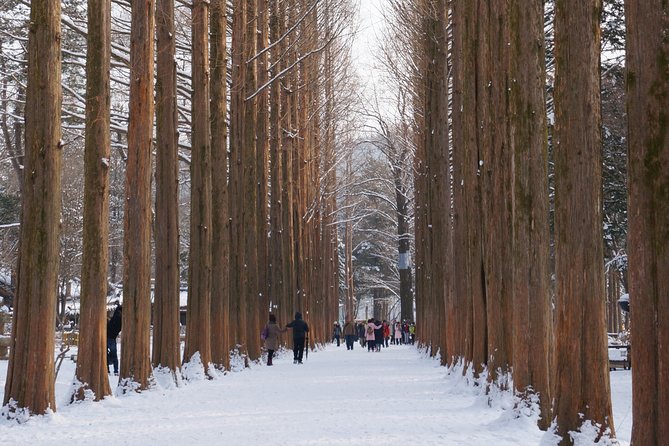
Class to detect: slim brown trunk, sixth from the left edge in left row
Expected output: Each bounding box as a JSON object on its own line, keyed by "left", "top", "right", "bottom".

{"left": 209, "top": 0, "right": 231, "bottom": 369}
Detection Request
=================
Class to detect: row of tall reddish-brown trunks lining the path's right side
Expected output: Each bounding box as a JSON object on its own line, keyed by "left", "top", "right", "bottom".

{"left": 404, "top": 0, "right": 669, "bottom": 445}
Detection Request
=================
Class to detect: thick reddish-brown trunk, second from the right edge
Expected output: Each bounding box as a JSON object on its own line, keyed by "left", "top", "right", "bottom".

{"left": 554, "top": 0, "right": 614, "bottom": 445}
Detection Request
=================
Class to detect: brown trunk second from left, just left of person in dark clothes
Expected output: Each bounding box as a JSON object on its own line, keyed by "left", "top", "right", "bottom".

{"left": 73, "top": 0, "right": 111, "bottom": 401}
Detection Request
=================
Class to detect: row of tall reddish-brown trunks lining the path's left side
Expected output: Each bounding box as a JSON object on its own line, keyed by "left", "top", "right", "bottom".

{"left": 4, "top": 0, "right": 350, "bottom": 413}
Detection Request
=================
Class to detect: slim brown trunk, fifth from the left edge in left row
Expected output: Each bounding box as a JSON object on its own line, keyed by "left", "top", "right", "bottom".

{"left": 184, "top": 0, "right": 212, "bottom": 372}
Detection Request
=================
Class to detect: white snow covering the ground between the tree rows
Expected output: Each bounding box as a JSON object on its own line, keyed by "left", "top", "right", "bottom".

{"left": 0, "top": 344, "right": 632, "bottom": 446}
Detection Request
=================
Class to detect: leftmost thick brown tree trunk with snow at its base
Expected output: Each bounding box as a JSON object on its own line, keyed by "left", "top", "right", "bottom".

{"left": 3, "top": 0, "right": 62, "bottom": 414}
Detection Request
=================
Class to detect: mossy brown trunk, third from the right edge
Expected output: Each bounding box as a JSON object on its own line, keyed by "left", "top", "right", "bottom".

{"left": 508, "top": 0, "right": 552, "bottom": 429}
